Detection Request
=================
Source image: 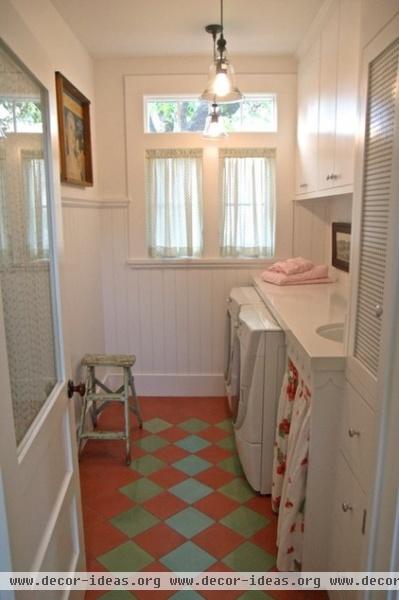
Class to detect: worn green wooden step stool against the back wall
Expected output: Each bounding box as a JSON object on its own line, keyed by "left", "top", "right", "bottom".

{"left": 78, "top": 354, "right": 143, "bottom": 465}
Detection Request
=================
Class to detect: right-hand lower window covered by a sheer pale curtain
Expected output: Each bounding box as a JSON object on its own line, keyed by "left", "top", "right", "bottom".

{"left": 220, "top": 148, "right": 276, "bottom": 258}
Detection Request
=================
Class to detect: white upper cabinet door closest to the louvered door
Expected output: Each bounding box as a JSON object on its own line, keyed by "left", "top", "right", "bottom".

{"left": 332, "top": 0, "right": 360, "bottom": 187}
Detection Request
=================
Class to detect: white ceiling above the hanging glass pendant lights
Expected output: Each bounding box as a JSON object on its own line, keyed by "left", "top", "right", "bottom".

{"left": 51, "top": 0, "right": 323, "bottom": 58}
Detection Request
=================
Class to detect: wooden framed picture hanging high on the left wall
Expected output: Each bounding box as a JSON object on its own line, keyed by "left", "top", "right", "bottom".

{"left": 55, "top": 71, "right": 93, "bottom": 186}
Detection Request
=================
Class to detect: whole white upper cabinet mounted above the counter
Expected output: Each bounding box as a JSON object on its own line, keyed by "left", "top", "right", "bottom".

{"left": 296, "top": 0, "right": 360, "bottom": 198}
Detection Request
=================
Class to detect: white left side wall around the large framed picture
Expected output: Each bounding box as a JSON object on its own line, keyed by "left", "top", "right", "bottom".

{"left": 0, "top": 0, "right": 104, "bottom": 384}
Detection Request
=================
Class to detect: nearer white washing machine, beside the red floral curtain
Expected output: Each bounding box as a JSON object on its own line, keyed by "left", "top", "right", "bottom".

{"left": 231, "top": 305, "right": 286, "bottom": 494}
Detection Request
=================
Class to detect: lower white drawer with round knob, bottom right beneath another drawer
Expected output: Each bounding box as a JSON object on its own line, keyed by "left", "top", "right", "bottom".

{"left": 329, "top": 453, "right": 367, "bottom": 571}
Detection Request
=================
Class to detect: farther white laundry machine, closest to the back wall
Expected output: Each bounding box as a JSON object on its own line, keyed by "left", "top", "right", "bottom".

{"left": 224, "top": 286, "right": 263, "bottom": 413}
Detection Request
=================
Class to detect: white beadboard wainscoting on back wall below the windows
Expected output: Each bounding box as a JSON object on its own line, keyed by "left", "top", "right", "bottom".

{"left": 101, "top": 208, "right": 270, "bottom": 396}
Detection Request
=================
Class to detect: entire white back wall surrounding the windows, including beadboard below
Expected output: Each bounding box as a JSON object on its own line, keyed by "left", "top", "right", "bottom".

{"left": 95, "top": 57, "right": 296, "bottom": 395}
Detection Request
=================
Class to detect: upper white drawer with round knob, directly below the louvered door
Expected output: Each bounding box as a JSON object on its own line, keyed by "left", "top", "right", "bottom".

{"left": 339, "top": 382, "right": 375, "bottom": 494}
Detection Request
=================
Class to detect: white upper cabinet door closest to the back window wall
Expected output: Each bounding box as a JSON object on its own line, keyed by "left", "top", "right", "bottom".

{"left": 296, "top": 40, "right": 320, "bottom": 194}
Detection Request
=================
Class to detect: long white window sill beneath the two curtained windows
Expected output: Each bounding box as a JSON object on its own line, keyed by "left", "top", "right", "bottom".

{"left": 126, "top": 257, "right": 279, "bottom": 269}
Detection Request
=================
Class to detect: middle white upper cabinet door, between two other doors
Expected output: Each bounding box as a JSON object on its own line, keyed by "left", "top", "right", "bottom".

{"left": 318, "top": 2, "right": 339, "bottom": 190}
